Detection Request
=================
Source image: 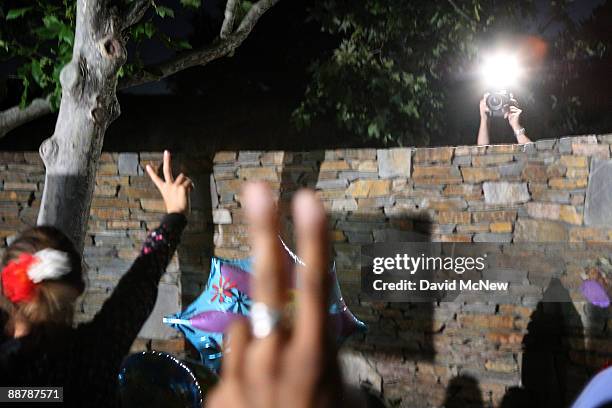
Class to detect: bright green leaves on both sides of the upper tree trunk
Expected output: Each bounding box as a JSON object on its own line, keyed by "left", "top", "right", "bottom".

{"left": 0, "top": 0, "right": 201, "bottom": 109}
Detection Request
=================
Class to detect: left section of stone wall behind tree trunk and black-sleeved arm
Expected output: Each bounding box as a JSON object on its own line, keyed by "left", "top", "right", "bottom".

{"left": 0, "top": 152, "right": 212, "bottom": 352}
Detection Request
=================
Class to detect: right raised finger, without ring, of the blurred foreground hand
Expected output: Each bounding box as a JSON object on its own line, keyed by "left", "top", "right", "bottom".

{"left": 293, "top": 190, "right": 330, "bottom": 348}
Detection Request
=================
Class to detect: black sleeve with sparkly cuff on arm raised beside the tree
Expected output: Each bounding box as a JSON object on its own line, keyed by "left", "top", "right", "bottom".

{"left": 79, "top": 214, "right": 187, "bottom": 358}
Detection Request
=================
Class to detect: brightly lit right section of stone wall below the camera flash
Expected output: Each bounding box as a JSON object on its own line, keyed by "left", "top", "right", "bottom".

{"left": 211, "top": 135, "right": 612, "bottom": 407}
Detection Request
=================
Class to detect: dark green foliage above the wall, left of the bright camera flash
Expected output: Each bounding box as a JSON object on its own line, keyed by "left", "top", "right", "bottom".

{"left": 294, "top": 0, "right": 601, "bottom": 144}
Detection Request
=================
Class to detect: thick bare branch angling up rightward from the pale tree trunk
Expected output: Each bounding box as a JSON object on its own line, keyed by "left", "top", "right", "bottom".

{"left": 119, "top": 0, "right": 279, "bottom": 89}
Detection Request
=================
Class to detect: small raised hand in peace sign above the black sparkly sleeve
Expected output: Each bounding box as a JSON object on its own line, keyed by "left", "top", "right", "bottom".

{"left": 147, "top": 150, "right": 193, "bottom": 214}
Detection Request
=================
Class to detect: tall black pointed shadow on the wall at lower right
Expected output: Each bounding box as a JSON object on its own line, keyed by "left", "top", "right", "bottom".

{"left": 500, "top": 278, "right": 589, "bottom": 408}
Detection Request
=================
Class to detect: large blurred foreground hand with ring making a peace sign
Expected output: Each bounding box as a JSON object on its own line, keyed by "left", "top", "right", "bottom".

{"left": 207, "top": 183, "right": 342, "bottom": 408}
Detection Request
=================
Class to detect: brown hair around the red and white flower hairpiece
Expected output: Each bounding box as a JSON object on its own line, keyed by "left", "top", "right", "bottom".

{"left": 2, "top": 226, "right": 85, "bottom": 331}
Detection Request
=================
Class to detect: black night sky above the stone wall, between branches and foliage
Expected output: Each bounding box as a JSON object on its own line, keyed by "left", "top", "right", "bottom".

{"left": 0, "top": 0, "right": 605, "bottom": 150}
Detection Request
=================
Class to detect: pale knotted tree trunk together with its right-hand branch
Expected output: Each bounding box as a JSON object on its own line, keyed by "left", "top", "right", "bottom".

{"left": 33, "top": 0, "right": 278, "bottom": 250}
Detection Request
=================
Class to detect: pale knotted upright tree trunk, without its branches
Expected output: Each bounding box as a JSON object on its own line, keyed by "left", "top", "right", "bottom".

{"left": 38, "top": 0, "right": 126, "bottom": 250}
